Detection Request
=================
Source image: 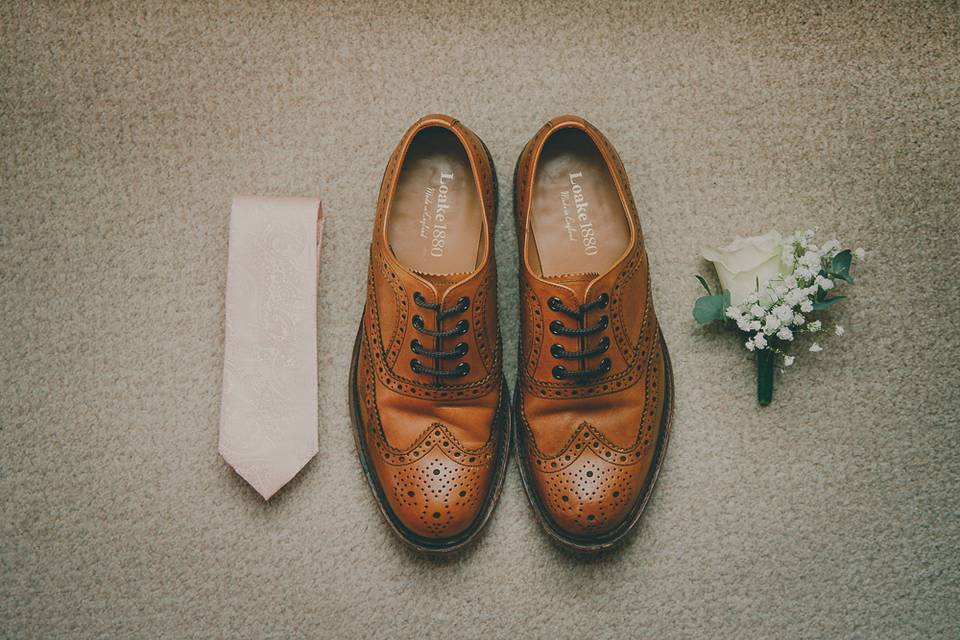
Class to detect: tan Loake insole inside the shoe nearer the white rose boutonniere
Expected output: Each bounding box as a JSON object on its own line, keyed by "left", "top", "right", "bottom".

{"left": 529, "top": 129, "right": 630, "bottom": 277}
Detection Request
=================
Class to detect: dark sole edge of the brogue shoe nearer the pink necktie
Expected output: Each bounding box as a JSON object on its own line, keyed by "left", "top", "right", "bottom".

{"left": 349, "top": 135, "right": 513, "bottom": 556}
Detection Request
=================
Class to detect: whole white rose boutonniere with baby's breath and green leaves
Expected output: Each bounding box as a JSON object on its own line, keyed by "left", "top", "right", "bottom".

{"left": 693, "top": 231, "right": 865, "bottom": 406}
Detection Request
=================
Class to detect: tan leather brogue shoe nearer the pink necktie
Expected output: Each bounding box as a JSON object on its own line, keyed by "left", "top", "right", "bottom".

{"left": 350, "top": 115, "right": 511, "bottom": 552}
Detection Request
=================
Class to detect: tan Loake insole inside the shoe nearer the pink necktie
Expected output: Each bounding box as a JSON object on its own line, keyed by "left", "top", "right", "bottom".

{"left": 387, "top": 127, "right": 483, "bottom": 275}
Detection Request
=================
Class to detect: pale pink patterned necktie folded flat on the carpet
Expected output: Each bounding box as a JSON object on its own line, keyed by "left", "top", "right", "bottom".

{"left": 220, "top": 197, "right": 323, "bottom": 499}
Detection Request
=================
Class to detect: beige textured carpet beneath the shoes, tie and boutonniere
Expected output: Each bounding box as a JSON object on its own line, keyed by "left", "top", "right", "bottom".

{"left": 0, "top": 0, "right": 960, "bottom": 639}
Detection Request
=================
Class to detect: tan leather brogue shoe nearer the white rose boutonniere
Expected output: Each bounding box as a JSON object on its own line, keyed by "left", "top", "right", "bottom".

{"left": 514, "top": 116, "right": 673, "bottom": 551}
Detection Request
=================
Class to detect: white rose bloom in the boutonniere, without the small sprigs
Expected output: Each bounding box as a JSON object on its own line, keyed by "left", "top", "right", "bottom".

{"left": 703, "top": 231, "right": 787, "bottom": 306}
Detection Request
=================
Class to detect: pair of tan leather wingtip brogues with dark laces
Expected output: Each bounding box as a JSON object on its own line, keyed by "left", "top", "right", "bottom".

{"left": 350, "top": 115, "right": 673, "bottom": 552}
